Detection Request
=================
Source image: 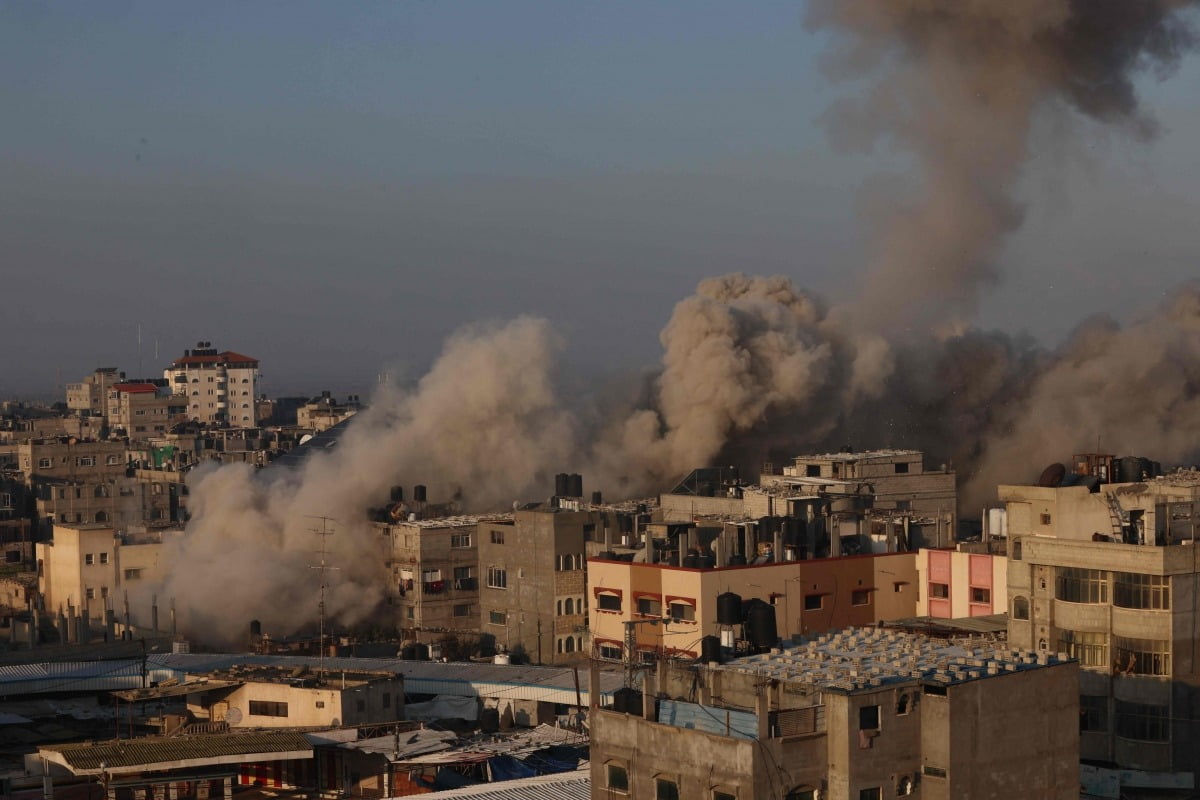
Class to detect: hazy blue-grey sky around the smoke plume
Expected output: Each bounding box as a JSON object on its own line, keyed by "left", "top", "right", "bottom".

{"left": 0, "top": 0, "right": 1200, "bottom": 397}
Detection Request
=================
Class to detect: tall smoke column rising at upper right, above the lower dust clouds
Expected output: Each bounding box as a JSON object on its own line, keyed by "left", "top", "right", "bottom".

{"left": 808, "top": 0, "right": 1195, "bottom": 336}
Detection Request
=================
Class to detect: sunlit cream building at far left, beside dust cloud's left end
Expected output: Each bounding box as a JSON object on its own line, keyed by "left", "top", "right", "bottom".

{"left": 36, "top": 524, "right": 163, "bottom": 620}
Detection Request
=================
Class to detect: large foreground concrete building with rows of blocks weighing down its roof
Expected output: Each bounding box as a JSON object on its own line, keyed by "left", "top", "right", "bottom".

{"left": 588, "top": 627, "right": 1080, "bottom": 800}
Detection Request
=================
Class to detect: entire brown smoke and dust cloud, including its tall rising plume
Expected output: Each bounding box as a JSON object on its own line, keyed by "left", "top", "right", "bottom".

{"left": 160, "top": 0, "right": 1200, "bottom": 643}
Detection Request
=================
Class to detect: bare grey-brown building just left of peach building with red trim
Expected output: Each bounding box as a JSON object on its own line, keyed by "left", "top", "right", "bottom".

{"left": 479, "top": 505, "right": 599, "bottom": 663}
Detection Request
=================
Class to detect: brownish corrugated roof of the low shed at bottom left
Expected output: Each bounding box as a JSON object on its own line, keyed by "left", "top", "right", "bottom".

{"left": 38, "top": 730, "right": 312, "bottom": 775}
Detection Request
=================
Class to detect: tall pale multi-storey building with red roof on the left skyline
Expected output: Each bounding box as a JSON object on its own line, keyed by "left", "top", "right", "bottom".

{"left": 163, "top": 342, "right": 258, "bottom": 427}
